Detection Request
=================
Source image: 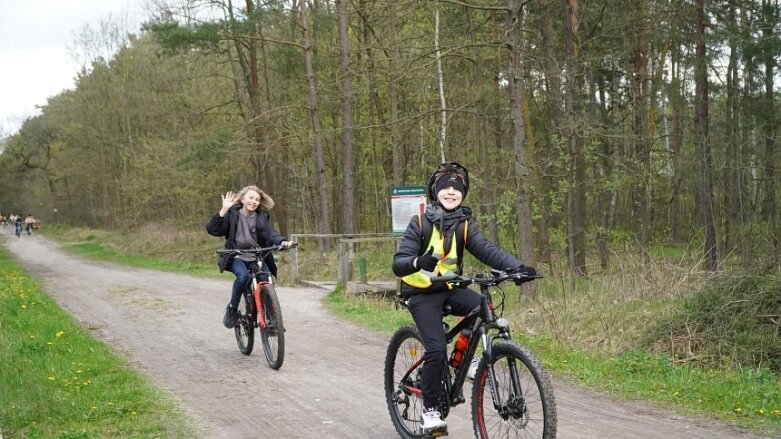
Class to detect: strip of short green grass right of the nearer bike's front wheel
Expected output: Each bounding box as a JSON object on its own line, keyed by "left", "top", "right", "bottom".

{"left": 520, "top": 337, "right": 781, "bottom": 433}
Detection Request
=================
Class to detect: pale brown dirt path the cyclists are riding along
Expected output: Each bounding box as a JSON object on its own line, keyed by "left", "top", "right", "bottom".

{"left": 0, "top": 232, "right": 769, "bottom": 439}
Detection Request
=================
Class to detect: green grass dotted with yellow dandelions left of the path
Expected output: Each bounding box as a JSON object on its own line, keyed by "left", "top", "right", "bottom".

{"left": 0, "top": 249, "right": 195, "bottom": 439}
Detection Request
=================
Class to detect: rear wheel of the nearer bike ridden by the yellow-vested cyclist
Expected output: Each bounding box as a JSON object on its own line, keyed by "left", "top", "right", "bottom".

{"left": 384, "top": 325, "right": 428, "bottom": 439}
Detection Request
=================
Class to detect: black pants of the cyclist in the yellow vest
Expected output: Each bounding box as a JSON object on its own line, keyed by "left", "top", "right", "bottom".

{"left": 407, "top": 288, "right": 480, "bottom": 407}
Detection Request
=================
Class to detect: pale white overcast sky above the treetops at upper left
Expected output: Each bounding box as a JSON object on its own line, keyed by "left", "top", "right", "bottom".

{"left": 0, "top": 0, "right": 145, "bottom": 137}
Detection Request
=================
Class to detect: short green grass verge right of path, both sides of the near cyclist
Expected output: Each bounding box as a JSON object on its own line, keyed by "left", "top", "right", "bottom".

{"left": 326, "top": 290, "right": 781, "bottom": 434}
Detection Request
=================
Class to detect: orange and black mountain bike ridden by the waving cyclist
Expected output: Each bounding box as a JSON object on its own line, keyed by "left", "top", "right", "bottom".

{"left": 217, "top": 242, "right": 298, "bottom": 370}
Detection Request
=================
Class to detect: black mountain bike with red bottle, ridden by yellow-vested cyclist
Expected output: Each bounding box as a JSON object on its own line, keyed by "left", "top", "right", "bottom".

{"left": 384, "top": 270, "right": 556, "bottom": 439}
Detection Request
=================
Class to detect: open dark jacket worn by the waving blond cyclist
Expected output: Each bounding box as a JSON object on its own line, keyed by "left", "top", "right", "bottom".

{"left": 206, "top": 206, "right": 285, "bottom": 276}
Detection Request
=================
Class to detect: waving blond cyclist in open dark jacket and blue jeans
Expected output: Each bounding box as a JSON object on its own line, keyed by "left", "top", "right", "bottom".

{"left": 206, "top": 186, "right": 290, "bottom": 328}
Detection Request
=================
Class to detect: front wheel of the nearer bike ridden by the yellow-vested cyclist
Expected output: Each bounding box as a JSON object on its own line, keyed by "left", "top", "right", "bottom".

{"left": 472, "top": 342, "right": 556, "bottom": 439}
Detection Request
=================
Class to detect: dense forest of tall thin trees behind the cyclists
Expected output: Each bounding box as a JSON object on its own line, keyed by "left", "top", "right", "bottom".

{"left": 0, "top": 0, "right": 781, "bottom": 275}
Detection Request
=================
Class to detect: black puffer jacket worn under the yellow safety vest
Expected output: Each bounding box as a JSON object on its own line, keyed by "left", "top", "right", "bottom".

{"left": 393, "top": 205, "right": 523, "bottom": 296}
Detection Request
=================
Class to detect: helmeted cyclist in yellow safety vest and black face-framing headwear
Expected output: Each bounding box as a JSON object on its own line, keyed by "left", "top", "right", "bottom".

{"left": 393, "top": 162, "right": 536, "bottom": 433}
